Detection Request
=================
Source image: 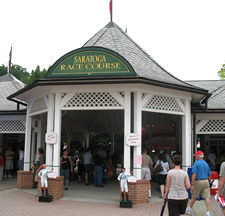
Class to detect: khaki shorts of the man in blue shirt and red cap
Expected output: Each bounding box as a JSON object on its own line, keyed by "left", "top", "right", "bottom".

{"left": 192, "top": 179, "right": 210, "bottom": 199}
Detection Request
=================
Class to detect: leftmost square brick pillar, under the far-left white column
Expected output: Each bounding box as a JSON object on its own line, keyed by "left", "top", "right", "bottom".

{"left": 17, "top": 170, "right": 34, "bottom": 189}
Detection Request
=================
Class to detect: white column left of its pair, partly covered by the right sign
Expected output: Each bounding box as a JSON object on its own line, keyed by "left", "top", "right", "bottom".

{"left": 123, "top": 91, "right": 131, "bottom": 173}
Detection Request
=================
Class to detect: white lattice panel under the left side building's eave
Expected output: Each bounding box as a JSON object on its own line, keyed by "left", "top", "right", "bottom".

{"left": 0, "top": 120, "right": 26, "bottom": 133}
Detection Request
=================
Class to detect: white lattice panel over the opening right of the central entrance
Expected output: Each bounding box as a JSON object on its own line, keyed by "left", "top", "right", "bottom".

{"left": 143, "top": 95, "right": 183, "bottom": 113}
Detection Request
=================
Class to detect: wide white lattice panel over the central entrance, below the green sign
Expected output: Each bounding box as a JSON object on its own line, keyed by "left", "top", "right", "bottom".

{"left": 63, "top": 92, "right": 123, "bottom": 109}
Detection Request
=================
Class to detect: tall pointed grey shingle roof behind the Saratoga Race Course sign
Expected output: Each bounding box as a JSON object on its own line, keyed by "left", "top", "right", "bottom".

{"left": 83, "top": 22, "right": 204, "bottom": 91}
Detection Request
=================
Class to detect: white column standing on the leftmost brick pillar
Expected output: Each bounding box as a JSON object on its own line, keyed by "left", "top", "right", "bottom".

{"left": 23, "top": 105, "right": 32, "bottom": 171}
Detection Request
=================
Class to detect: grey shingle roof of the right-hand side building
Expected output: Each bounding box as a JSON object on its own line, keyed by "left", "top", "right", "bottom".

{"left": 186, "top": 80, "right": 225, "bottom": 109}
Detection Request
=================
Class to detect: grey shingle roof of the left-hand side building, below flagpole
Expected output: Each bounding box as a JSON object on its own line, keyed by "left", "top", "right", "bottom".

{"left": 0, "top": 74, "right": 26, "bottom": 111}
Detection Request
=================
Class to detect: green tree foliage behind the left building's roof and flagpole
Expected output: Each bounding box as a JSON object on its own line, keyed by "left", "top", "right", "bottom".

{"left": 0, "top": 64, "right": 48, "bottom": 85}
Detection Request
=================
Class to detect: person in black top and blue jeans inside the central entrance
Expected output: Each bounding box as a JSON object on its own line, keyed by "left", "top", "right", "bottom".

{"left": 94, "top": 149, "right": 104, "bottom": 187}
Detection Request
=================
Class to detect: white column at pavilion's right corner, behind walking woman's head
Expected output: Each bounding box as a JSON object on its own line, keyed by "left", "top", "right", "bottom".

{"left": 182, "top": 99, "right": 192, "bottom": 170}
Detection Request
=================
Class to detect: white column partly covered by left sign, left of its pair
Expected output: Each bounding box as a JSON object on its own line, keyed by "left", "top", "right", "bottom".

{"left": 45, "top": 94, "right": 54, "bottom": 168}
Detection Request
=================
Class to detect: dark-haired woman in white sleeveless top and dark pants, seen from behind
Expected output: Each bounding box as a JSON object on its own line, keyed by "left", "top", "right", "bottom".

{"left": 164, "top": 154, "right": 191, "bottom": 216}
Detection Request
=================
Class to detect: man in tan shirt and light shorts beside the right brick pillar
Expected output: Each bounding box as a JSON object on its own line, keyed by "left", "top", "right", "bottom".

{"left": 141, "top": 149, "right": 153, "bottom": 198}
